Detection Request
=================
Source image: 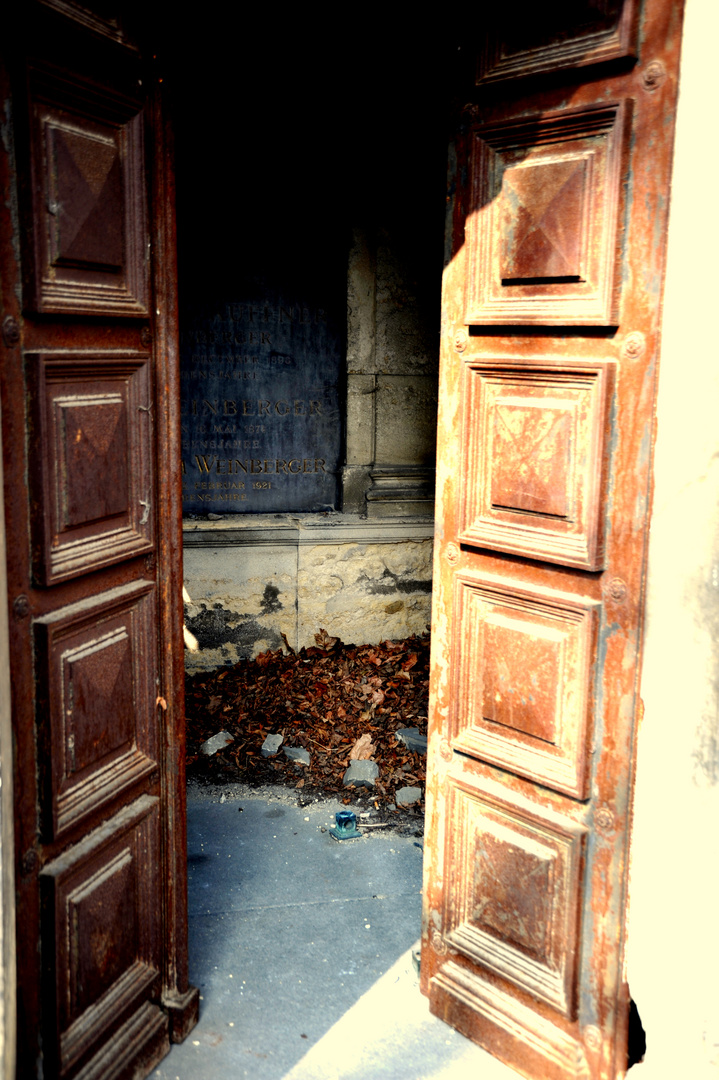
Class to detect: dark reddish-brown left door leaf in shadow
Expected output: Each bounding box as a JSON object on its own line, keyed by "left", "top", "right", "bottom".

{"left": 0, "top": 2, "right": 198, "bottom": 1080}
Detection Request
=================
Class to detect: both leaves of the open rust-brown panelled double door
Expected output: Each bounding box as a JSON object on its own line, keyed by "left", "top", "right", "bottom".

{"left": 0, "top": 0, "right": 682, "bottom": 1080}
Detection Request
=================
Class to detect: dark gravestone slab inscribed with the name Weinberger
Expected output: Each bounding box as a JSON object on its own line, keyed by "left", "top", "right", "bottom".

{"left": 180, "top": 288, "right": 344, "bottom": 514}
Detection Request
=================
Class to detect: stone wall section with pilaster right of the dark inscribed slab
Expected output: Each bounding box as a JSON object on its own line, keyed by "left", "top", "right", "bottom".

{"left": 342, "top": 225, "right": 440, "bottom": 517}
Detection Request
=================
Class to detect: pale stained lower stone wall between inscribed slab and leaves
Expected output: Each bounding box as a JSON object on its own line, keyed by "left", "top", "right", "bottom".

{"left": 184, "top": 513, "right": 433, "bottom": 672}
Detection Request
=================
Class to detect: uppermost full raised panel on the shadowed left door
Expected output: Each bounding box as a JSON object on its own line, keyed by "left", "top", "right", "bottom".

{"left": 26, "top": 71, "right": 148, "bottom": 315}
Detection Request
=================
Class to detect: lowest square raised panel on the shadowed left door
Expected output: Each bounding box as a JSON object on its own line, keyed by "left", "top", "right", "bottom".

{"left": 42, "top": 795, "right": 160, "bottom": 1075}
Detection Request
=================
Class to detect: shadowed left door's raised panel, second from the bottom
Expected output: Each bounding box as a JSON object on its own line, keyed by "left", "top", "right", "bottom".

{"left": 36, "top": 581, "right": 158, "bottom": 837}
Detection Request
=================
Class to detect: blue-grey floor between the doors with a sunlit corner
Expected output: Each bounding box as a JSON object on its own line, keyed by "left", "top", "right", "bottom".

{"left": 151, "top": 785, "right": 516, "bottom": 1080}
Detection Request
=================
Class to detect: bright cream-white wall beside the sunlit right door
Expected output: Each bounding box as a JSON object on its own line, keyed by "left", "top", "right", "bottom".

{"left": 627, "top": 0, "right": 719, "bottom": 1080}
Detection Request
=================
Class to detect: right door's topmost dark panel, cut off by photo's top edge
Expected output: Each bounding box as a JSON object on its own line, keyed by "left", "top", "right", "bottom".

{"left": 477, "top": 0, "right": 639, "bottom": 85}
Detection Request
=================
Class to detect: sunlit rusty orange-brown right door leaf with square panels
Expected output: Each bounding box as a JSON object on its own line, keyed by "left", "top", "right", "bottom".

{"left": 422, "top": 0, "right": 682, "bottom": 1080}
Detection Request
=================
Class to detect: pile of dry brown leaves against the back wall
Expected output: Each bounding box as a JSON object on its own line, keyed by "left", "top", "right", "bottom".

{"left": 186, "top": 630, "right": 430, "bottom": 806}
